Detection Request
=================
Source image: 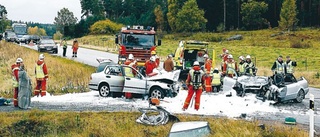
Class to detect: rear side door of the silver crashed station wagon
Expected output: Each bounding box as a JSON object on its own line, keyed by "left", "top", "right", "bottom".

{"left": 105, "top": 66, "right": 124, "bottom": 92}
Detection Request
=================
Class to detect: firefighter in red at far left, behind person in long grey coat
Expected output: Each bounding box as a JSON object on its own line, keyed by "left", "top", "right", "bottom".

{"left": 11, "top": 58, "right": 23, "bottom": 107}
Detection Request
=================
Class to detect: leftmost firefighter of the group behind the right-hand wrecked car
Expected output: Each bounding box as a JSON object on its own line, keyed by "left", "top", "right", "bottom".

{"left": 222, "top": 54, "right": 238, "bottom": 78}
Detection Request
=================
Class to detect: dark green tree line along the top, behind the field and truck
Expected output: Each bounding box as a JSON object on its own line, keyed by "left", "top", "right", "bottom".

{"left": 1, "top": 0, "right": 320, "bottom": 37}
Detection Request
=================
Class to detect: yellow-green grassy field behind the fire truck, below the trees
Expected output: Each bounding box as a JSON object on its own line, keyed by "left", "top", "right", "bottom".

{"left": 79, "top": 28, "right": 320, "bottom": 87}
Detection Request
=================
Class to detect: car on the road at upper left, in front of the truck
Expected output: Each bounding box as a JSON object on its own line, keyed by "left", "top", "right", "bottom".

{"left": 38, "top": 39, "right": 58, "bottom": 54}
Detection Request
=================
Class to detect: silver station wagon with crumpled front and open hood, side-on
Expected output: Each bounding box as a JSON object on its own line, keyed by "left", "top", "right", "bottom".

{"left": 89, "top": 63, "right": 180, "bottom": 98}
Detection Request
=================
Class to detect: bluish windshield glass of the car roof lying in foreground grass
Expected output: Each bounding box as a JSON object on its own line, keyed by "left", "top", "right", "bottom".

{"left": 169, "top": 126, "right": 210, "bottom": 137}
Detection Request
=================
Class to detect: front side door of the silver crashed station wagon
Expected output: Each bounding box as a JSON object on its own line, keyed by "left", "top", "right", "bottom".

{"left": 122, "top": 66, "right": 147, "bottom": 94}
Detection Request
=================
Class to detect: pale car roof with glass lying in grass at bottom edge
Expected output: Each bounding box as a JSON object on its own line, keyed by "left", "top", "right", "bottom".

{"left": 169, "top": 121, "right": 211, "bottom": 137}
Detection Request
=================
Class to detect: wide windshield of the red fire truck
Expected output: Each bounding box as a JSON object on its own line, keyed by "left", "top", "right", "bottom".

{"left": 122, "top": 34, "right": 155, "bottom": 47}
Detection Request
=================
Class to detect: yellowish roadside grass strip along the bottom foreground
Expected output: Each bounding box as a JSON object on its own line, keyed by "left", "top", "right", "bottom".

{"left": 0, "top": 110, "right": 308, "bottom": 137}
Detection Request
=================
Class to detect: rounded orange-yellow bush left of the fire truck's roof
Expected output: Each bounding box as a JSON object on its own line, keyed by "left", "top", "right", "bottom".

{"left": 89, "top": 19, "right": 123, "bottom": 34}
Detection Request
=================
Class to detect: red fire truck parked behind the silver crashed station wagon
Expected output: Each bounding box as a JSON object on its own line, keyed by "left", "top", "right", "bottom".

{"left": 115, "top": 26, "right": 161, "bottom": 66}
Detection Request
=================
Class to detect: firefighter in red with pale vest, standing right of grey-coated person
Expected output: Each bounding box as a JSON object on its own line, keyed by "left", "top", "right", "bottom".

{"left": 34, "top": 54, "right": 48, "bottom": 97}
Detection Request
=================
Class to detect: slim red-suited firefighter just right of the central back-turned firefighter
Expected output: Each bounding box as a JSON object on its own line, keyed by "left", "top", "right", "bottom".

{"left": 203, "top": 54, "right": 212, "bottom": 92}
